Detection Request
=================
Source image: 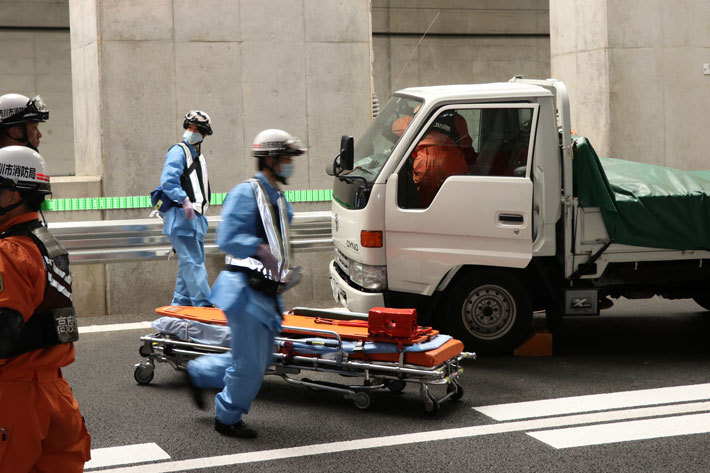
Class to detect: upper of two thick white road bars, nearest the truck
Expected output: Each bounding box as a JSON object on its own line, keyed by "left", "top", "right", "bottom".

{"left": 474, "top": 384, "right": 710, "bottom": 421}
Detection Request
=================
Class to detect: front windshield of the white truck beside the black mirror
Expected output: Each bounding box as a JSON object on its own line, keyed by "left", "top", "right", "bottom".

{"left": 333, "top": 96, "right": 422, "bottom": 209}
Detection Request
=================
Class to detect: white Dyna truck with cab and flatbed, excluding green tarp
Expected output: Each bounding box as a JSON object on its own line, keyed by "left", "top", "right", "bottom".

{"left": 327, "top": 76, "right": 710, "bottom": 353}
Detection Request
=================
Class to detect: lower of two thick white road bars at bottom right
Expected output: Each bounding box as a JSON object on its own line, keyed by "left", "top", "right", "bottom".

{"left": 528, "top": 414, "right": 710, "bottom": 449}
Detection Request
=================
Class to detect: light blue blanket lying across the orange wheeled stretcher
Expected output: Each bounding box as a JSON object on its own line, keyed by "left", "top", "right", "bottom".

{"left": 152, "top": 317, "right": 452, "bottom": 355}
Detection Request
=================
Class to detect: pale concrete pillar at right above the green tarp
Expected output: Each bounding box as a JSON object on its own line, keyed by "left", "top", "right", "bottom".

{"left": 550, "top": 0, "right": 710, "bottom": 169}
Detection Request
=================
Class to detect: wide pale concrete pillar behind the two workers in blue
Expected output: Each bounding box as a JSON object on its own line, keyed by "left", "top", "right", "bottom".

{"left": 69, "top": 0, "right": 372, "bottom": 314}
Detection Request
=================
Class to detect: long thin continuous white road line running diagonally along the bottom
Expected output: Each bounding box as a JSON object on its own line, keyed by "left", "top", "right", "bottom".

{"left": 101, "top": 401, "right": 710, "bottom": 473}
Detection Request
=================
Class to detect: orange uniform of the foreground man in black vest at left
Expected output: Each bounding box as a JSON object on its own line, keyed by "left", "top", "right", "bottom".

{"left": 0, "top": 212, "right": 91, "bottom": 473}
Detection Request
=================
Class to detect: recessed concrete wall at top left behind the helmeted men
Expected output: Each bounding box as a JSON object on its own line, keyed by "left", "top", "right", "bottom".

{"left": 0, "top": 0, "right": 74, "bottom": 175}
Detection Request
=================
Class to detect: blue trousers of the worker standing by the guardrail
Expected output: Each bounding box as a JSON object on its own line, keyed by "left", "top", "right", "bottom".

{"left": 168, "top": 235, "right": 212, "bottom": 307}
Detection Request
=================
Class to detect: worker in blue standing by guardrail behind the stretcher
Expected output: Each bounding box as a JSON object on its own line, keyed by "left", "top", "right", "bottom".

{"left": 160, "top": 110, "right": 212, "bottom": 307}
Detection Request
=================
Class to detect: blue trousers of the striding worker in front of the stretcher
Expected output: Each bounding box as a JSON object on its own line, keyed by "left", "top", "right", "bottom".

{"left": 187, "top": 311, "right": 276, "bottom": 425}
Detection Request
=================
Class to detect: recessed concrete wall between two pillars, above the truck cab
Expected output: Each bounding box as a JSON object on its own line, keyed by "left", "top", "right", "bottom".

{"left": 372, "top": 0, "right": 550, "bottom": 102}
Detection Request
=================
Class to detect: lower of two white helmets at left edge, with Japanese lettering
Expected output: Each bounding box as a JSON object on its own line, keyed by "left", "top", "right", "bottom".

{"left": 0, "top": 146, "right": 52, "bottom": 195}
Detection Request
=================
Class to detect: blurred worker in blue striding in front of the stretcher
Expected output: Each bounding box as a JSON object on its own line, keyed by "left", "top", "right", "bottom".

{"left": 187, "top": 129, "right": 306, "bottom": 437}
